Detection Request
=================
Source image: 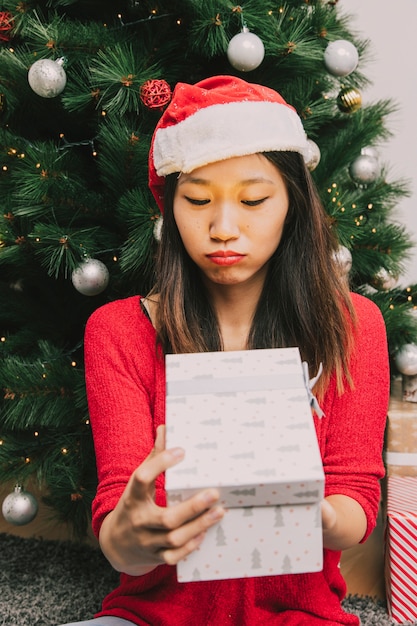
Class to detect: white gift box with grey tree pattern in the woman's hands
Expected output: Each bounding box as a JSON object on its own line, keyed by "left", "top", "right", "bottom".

{"left": 166, "top": 348, "right": 324, "bottom": 582}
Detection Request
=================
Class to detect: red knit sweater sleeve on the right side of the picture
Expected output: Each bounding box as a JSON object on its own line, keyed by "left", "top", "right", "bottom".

{"left": 316, "top": 294, "right": 390, "bottom": 541}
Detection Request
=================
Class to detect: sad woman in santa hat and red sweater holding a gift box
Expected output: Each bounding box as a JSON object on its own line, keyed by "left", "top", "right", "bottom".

{"left": 62, "top": 76, "right": 389, "bottom": 626}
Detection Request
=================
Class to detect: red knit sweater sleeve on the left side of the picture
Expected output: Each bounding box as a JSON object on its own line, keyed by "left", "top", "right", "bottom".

{"left": 84, "top": 298, "right": 165, "bottom": 536}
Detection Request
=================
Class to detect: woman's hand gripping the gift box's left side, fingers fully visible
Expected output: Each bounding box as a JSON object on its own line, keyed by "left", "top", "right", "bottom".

{"left": 99, "top": 426, "right": 224, "bottom": 576}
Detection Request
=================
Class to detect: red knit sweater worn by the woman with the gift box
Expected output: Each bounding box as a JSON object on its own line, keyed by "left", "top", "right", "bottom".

{"left": 85, "top": 295, "right": 389, "bottom": 626}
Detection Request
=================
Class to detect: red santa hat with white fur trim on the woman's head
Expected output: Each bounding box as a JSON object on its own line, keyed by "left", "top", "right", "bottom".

{"left": 149, "top": 76, "right": 307, "bottom": 211}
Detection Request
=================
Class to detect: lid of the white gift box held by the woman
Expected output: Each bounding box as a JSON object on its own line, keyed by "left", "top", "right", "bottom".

{"left": 165, "top": 348, "right": 324, "bottom": 507}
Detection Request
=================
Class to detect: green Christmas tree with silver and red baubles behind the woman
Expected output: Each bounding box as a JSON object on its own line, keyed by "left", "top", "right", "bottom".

{"left": 0, "top": 0, "right": 417, "bottom": 537}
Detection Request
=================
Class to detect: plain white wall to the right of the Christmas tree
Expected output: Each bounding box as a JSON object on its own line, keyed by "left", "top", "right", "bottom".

{"left": 337, "top": 0, "right": 417, "bottom": 286}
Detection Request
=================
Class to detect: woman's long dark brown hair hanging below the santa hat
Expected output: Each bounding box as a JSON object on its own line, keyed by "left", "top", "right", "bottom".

{"left": 153, "top": 152, "right": 354, "bottom": 392}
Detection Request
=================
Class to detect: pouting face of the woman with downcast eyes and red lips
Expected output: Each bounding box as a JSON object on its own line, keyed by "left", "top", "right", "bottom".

{"left": 174, "top": 154, "right": 289, "bottom": 285}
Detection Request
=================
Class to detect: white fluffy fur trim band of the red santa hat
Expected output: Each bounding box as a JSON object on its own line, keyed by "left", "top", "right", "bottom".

{"left": 153, "top": 101, "right": 307, "bottom": 176}
